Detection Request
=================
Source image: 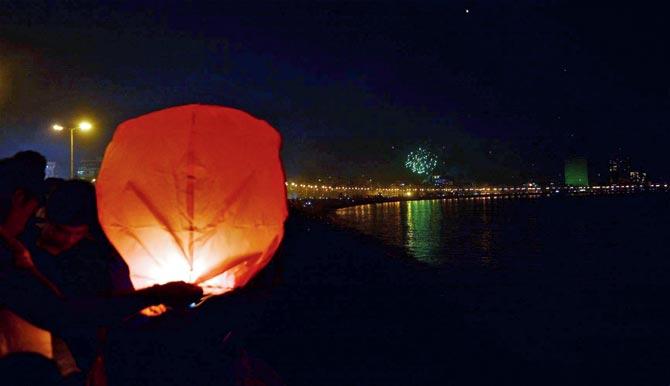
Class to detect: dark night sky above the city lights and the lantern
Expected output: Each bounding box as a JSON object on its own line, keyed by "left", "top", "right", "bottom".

{"left": 0, "top": 1, "right": 670, "bottom": 183}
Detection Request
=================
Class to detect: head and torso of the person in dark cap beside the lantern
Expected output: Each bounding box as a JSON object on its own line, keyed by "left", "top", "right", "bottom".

{"left": 22, "top": 180, "right": 133, "bottom": 296}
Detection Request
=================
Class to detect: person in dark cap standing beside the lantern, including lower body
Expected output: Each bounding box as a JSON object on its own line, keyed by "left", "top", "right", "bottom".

{"left": 21, "top": 180, "right": 134, "bottom": 374}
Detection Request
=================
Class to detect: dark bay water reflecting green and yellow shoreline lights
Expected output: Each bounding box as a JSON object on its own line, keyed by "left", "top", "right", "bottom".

{"left": 334, "top": 194, "right": 670, "bottom": 384}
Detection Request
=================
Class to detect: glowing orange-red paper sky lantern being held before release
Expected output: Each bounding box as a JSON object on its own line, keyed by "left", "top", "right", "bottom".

{"left": 96, "top": 105, "right": 288, "bottom": 293}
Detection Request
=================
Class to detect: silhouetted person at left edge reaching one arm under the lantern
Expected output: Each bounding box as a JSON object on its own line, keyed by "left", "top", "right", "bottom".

{"left": 0, "top": 152, "right": 202, "bottom": 384}
